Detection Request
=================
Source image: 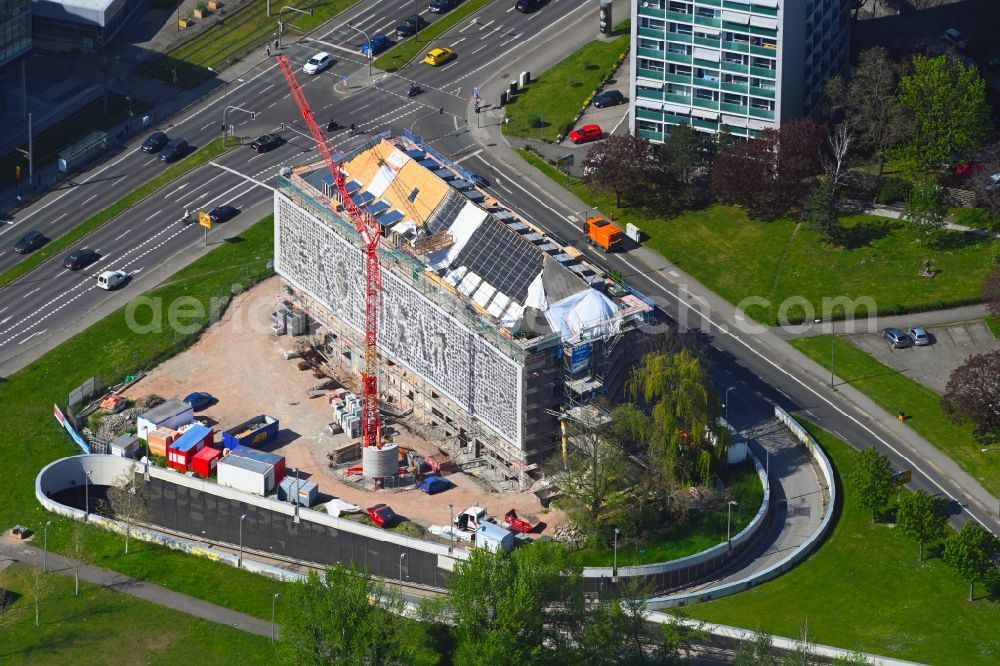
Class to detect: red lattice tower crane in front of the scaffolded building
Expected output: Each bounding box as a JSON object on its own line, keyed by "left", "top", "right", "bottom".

{"left": 278, "top": 55, "right": 382, "bottom": 448}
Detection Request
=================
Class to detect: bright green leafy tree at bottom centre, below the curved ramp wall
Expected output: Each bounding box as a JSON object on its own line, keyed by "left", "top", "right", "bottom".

{"left": 443, "top": 543, "right": 586, "bottom": 666}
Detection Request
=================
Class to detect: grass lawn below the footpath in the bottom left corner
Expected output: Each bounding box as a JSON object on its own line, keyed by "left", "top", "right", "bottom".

{"left": 0, "top": 562, "right": 273, "bottom": 664}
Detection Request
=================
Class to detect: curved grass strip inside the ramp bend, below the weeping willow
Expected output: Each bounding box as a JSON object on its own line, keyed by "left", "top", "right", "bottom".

{"left": 573, "top": 456, "right": 764, "bottom": 567}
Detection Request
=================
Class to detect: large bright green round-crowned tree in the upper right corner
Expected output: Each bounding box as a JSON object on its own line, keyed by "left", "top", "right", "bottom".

{"left": 899, "top": 55, "right": 991, "bottom": 173}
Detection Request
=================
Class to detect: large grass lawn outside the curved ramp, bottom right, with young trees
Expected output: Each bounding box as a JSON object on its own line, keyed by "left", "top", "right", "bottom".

{"left": 685, "top": 424, "right": 1000, "bottom": 664}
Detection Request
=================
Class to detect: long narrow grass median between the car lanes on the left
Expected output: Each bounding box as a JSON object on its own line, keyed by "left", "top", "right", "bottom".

{"left": 0, "top": 139, "right": 234, "bottom": 287}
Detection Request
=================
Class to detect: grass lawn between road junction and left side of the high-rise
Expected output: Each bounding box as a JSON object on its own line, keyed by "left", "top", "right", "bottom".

{"left": 503, "top": 34, "right": 630, "bottom": 141}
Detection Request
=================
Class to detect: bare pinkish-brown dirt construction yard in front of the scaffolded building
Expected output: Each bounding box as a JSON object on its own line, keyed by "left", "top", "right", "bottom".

{"left": 127, "top": 277, "right": 566, "bottom": 534}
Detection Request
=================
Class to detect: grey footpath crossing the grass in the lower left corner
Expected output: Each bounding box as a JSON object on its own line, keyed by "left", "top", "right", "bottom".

{"left": 0, "top": 534, "right": 271, "bottom": 637}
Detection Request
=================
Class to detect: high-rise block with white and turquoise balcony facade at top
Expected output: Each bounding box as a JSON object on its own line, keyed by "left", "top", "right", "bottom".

{"left": 630, "top": 0, "right": 851, "bottom": 141}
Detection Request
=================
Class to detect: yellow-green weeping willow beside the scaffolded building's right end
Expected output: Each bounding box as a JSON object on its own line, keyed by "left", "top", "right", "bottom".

{"left": 626, "top": 348, "right": 729, "bottom": 486}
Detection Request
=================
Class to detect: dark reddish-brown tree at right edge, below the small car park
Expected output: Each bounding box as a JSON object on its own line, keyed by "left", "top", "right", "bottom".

{"left": 941, "top": 349, "right": 1000, "bottom": 436}
